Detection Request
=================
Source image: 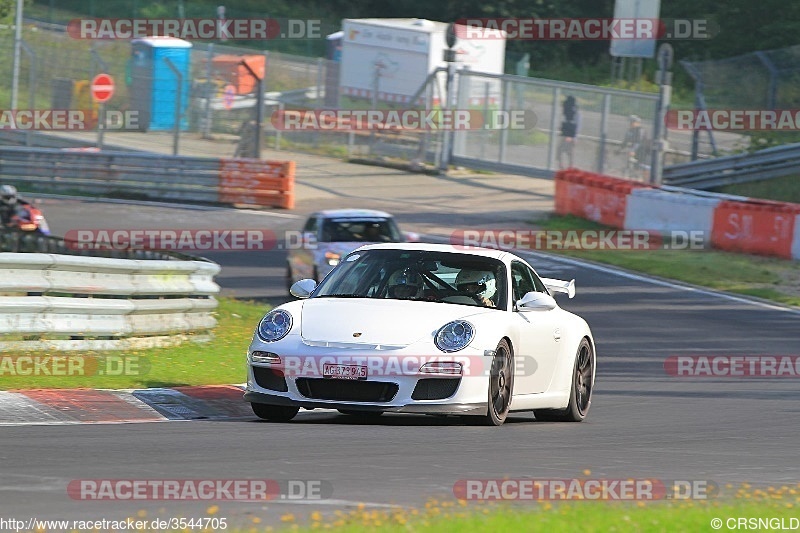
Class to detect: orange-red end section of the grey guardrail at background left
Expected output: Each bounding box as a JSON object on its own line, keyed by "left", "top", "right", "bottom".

{"left": 218, "top": 158, "right": 295, "bottom": 209}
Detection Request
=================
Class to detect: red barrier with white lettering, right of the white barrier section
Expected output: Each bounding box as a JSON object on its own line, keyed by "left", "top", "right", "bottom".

{"left": 711, "top": 200, "right": 800, "bottom": 259}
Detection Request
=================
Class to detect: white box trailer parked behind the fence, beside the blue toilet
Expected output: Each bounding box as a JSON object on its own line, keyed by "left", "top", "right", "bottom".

{"left": 339, "top": 19, "right": 506, "bottom": 103}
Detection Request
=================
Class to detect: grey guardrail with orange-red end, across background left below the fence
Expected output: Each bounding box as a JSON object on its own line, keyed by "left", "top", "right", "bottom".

{"left": 0, "top": 146, "right": 295, "bottom": 209}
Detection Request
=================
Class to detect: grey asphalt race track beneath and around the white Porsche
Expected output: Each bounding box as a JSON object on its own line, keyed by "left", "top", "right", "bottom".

{"left": 0, "top": 200, "right": 800, "bottom": 524}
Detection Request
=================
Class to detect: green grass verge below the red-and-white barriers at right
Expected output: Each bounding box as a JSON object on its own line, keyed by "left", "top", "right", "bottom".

{"left": 532, "top": 215, "right": 800, "bottom": 306}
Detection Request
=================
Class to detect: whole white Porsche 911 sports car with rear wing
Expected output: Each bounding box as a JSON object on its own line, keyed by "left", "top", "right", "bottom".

{"left": 245, "top": 243, "right": 596, "bottom": 425}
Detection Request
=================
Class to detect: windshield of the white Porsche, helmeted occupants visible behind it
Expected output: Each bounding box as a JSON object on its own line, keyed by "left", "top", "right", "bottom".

{"left": 312, "top": 250, "right": 506, "bottom": 309}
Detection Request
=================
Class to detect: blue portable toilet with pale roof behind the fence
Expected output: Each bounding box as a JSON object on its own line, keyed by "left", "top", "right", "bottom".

{"left": 129, "top": 37, "right": 192, "bottom": 131}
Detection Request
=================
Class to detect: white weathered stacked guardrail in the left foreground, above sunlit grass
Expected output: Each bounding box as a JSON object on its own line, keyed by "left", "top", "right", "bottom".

{"left": 0, "top": 252, "right": 220, "bottom": 350}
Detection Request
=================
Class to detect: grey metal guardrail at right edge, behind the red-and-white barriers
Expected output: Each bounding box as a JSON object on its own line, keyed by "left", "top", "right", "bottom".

{"left": 663, "top": 144, "right": 800, "bottom": 189}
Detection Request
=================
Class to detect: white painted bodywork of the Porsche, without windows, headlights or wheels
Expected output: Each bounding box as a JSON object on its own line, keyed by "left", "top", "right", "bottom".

{"left": 246, "top": 243, "right": 596, "bottom": 414}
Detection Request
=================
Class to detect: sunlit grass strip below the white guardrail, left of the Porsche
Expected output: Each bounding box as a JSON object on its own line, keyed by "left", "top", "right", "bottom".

{"left": 0, "top": 298, "right": 267, "bottom": 390}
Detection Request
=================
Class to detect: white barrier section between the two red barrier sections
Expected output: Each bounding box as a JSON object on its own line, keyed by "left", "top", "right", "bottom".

{"left": 625, "top": 185, "right": 722, "bottom": 241}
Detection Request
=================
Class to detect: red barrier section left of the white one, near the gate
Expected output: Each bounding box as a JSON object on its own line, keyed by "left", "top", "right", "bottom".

{"left": 555, "top": 169, "right": 650, "bottom": 228}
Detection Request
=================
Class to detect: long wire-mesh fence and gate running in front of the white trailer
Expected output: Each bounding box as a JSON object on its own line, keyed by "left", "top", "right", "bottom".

{"left": 0, "top": 20, "right": 720, "bottom": 180}
